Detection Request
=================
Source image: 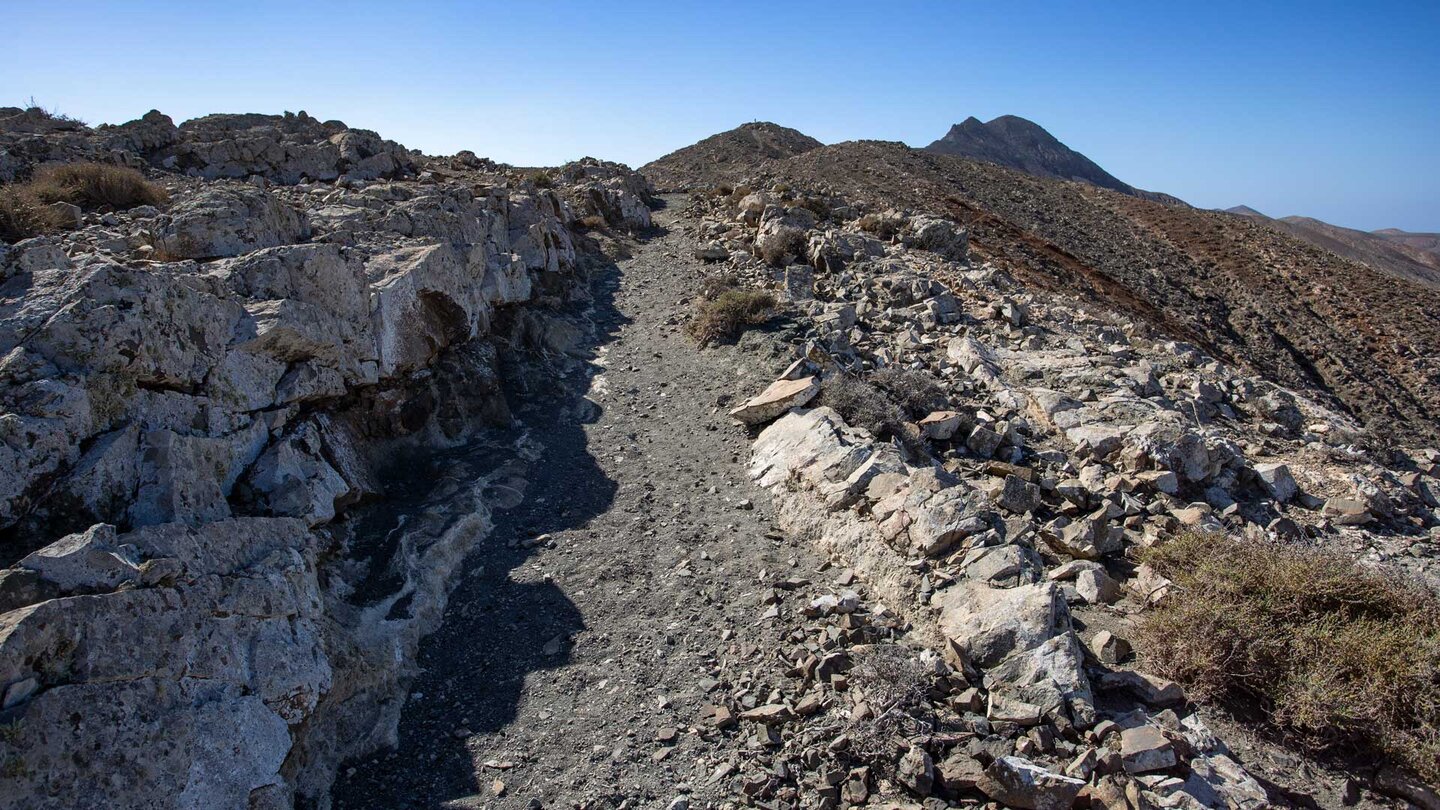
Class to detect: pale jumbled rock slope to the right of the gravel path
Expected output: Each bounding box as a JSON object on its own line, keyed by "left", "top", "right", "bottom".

{"left": 671, "top": 177, "right": 1440, "bottom": 809}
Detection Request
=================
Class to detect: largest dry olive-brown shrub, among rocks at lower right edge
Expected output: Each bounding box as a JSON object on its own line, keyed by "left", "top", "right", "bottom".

{"left": 1142, "top": 533, "right": 1440, "bottom": 784}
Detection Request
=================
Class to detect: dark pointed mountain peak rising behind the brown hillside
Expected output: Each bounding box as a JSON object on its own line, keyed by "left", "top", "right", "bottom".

{"left": 924, "top": 115, "right": 1184, "bottom": 205}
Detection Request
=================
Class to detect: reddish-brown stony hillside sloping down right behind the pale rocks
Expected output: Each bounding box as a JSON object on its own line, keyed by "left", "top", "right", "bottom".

{"left": 757, "top": 141, "right": 1440, "bottom": 441}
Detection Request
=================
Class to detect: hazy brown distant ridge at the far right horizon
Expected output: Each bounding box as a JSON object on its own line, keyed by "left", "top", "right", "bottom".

{"left": 1225, "top": 205, "right": 1440, "bottom": 290}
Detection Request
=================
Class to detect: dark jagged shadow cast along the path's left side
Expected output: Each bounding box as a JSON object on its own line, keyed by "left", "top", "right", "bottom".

{"left": 333, "top": 249, "right": 628, "bottom": 809}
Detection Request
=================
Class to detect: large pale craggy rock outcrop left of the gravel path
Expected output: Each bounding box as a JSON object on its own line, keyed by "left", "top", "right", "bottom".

{"left": 0, "top": 111, "right": 649, "bottom": 807}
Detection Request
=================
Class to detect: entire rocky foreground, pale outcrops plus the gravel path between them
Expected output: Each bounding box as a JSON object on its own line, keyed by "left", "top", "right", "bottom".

{"left": 0, "top": 111, "right": 1440, "bottom": 810}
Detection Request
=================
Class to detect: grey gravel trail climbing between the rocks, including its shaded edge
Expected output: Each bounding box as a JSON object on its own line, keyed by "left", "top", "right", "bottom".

{"left": 336, "top": 197, "right": 824, "bottom": 809}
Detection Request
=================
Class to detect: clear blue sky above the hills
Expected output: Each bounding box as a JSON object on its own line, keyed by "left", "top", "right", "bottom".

{"left": 0, "top": 0, "right": 1440, "bottom": 231}
